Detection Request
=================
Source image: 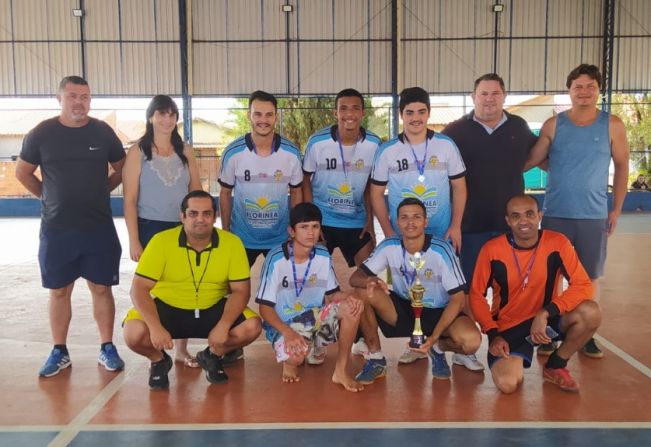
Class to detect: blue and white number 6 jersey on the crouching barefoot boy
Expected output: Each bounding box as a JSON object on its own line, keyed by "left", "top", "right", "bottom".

{"left": 255, "top": 242, "right": 339, "bottom": 324}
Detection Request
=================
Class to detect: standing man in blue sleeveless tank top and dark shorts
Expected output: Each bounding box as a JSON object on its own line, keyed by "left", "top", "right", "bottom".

{"left": 525, "top": 64, "right": 629, "bottom": 358}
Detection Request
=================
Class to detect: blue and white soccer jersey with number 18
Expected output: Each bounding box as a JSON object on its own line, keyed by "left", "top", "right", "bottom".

{"left": 371, "top": 130, "right": 466, "bottom": 237}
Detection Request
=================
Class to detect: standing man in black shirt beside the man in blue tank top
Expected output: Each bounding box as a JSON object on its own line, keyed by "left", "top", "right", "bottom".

{"left": 443, "top": 73, "right": 536, "bottom": 284}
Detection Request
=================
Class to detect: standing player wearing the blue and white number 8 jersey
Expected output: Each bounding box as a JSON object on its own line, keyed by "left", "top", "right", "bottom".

{"left": 219, "top": 90, "right": 303, "bottom": 265}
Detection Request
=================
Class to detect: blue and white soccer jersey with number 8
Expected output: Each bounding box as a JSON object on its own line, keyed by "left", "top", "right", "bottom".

{"left": 219, "top": 134, "right": 303, "bottom": 249}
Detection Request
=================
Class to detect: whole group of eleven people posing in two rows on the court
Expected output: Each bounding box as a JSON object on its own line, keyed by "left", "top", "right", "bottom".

{"left": 16, "top": 64, "right": 628, "bottom": 393}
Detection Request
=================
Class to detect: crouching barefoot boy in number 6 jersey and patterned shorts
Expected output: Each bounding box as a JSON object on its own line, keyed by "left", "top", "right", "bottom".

{"left": 256, "top": 203, "right": 364, "bottom": 392}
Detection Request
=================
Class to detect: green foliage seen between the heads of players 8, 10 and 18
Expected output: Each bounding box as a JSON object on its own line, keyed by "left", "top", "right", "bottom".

{"left": 222, "top": 98, "right": 389, "bottom": 155}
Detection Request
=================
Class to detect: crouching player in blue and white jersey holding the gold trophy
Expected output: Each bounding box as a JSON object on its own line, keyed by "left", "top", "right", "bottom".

{"left": 350, "top": 197, "right": 481, "bottom": 384}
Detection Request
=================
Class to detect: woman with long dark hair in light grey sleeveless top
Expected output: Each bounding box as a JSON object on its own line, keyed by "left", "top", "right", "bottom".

{"left": 122, "top": 95, "right": 202, "bottom": 367}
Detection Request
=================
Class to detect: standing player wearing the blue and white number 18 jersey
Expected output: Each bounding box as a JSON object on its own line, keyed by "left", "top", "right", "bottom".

{"left": 370, "top": 87, "right": 466, "bottom": 252}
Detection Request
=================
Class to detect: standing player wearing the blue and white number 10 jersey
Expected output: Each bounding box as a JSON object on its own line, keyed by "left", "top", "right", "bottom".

{"left": 303, "top": 88, "right": 380, "bottom": 267}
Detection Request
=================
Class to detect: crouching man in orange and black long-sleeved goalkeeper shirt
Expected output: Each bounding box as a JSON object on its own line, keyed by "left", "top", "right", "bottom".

{"left": 470, "top": 194, "right": 601, "bottom": 393}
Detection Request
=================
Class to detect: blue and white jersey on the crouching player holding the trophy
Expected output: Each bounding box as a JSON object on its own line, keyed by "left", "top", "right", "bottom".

{"left": 361, "top": 235, "right": 466, "bottom": 309}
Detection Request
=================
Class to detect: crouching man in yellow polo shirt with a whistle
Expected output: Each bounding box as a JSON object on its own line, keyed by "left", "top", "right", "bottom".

{"left": 123, "top": 191, "right": 261, "bottom": 389}
